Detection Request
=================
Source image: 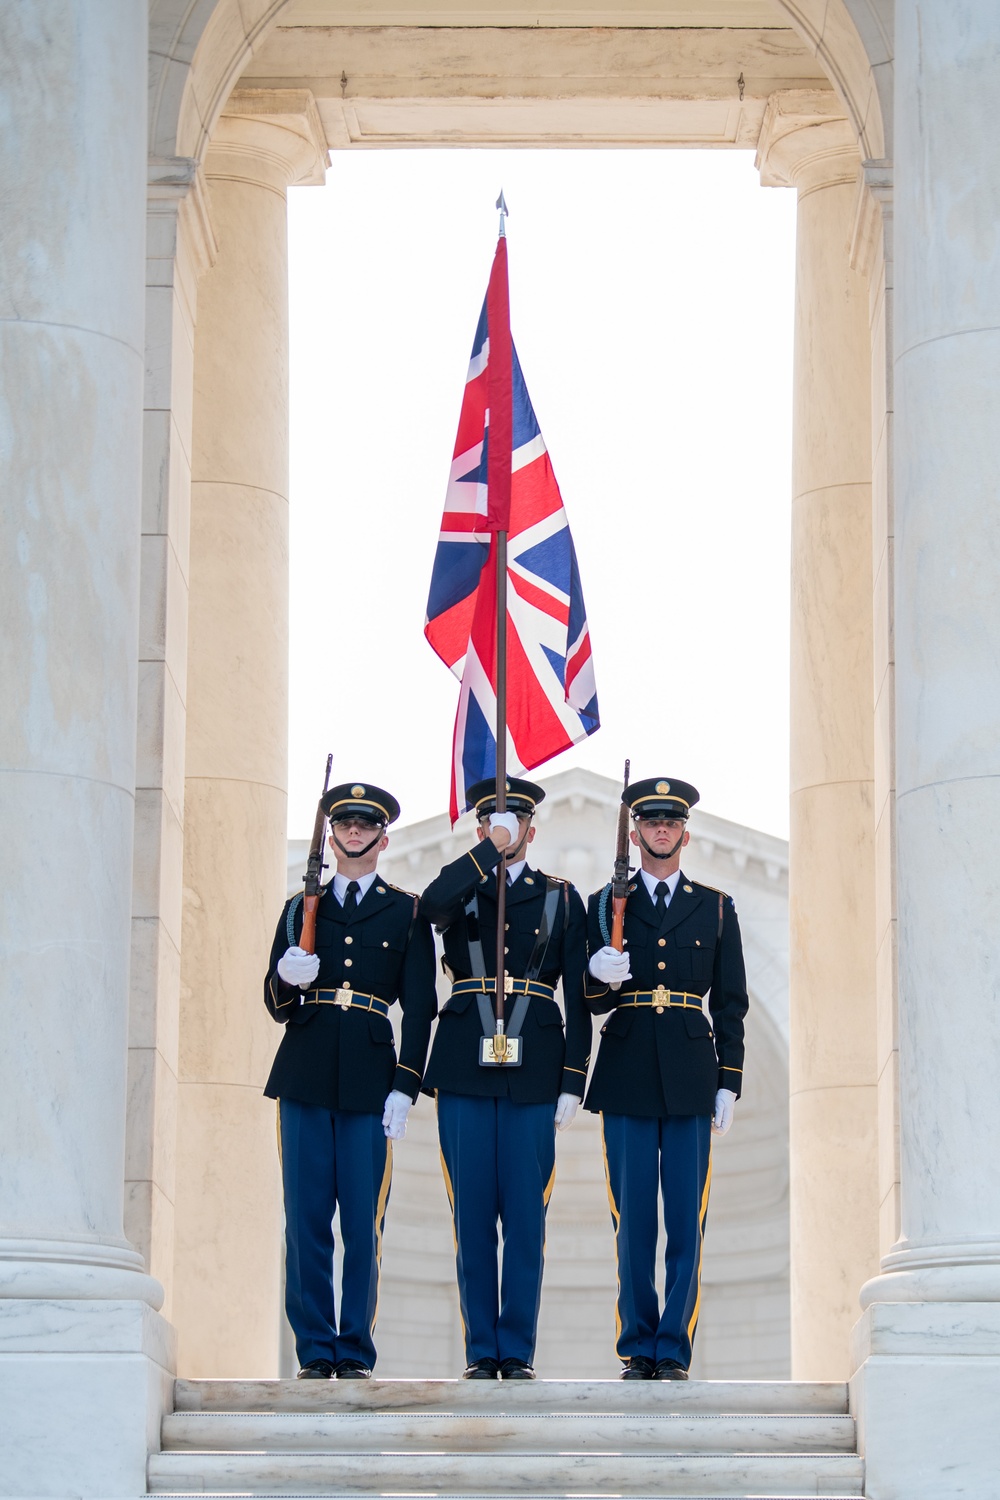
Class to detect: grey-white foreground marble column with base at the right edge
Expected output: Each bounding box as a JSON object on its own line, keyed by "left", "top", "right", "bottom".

{"left": 855, "top": 0, "right": 1000, "bottom": 1500}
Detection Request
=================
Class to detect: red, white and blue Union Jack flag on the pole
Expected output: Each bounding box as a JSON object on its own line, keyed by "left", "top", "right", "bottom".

{"left": 424, "top": 239, "right": 600, "bottom": 824}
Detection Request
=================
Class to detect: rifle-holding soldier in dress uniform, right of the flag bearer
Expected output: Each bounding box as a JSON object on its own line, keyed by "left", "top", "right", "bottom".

{"left": 585, "top": 777, "right": 747, "bottom": 1380}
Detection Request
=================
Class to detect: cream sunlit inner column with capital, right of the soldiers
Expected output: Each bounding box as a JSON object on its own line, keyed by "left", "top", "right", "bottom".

{"left": 757, "top": 90, "right": 879, "bottom": 1380}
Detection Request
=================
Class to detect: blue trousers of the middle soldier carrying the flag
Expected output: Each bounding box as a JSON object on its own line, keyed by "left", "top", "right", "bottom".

{"left": 438, "top": 1092, "right": 556, "bottom": 1365}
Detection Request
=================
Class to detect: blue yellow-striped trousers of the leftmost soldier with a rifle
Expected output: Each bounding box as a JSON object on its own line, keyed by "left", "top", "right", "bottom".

{"left": 279, "top": 1100, "right": 393, "bottom": 1370}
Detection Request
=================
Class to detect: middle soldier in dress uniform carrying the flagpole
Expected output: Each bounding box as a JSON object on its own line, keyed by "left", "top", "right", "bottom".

{"left": 420, "top": 777, "right": 592, "bottom": 1380}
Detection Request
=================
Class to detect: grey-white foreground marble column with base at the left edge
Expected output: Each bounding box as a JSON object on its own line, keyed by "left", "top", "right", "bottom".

{"left": 0, "top": 0, "right": 172, "bottom": 1496}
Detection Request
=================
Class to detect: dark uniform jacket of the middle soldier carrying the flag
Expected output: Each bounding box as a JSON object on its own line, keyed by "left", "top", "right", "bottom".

{"left": 420, "top": 839, "right": 592, "bottom": 1104}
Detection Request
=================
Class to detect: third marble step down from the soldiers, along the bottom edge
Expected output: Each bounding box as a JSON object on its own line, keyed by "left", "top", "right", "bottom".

{"left": 148, "top": 1451, "right": 864, "bottom": 1500}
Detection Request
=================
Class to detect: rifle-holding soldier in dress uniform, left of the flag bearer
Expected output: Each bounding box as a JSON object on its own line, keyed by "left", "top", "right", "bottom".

{"left": 264, "top": 782, "right": 436, "bottom": 1380}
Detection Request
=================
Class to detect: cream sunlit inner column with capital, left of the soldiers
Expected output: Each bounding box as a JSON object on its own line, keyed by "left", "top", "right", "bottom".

{"left": 174, "top": 90, "right": 327, "bottom": 1376}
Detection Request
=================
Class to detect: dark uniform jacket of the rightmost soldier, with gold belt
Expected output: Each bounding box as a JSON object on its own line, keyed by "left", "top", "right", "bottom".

{"left": 585, "top": 873, "right": 748, "bottom": 1116}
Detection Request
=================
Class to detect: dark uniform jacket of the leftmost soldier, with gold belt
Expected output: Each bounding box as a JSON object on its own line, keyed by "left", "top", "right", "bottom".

{"left": 264, "top": 876, "right": 438, "bottom": 1115}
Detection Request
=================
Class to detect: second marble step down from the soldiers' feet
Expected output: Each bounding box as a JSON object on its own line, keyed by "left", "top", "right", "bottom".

{"left": 162, "top": 1410, "right": 856, "bottom": 1454}
